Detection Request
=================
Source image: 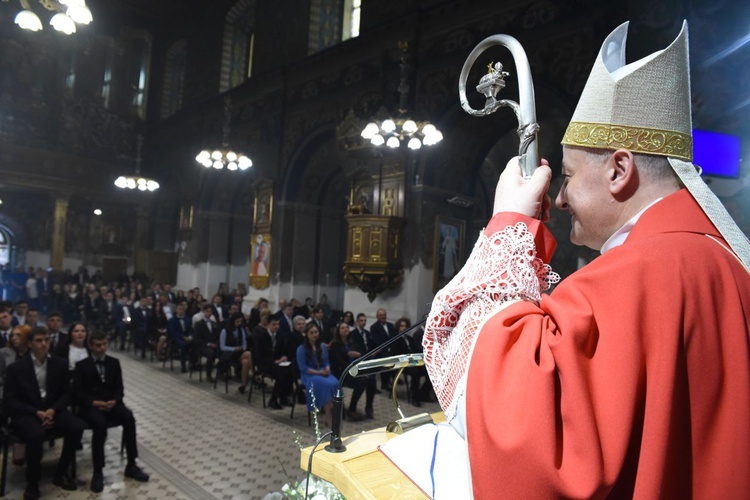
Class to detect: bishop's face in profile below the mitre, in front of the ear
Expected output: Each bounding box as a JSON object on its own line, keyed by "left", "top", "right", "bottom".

{"left": 555, "top": 146, "right": 617, "bottom": 250}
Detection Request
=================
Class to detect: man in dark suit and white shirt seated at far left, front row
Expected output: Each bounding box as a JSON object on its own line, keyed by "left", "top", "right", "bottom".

{"left": 3, "top": 326, "right": 84, "bottom": 499}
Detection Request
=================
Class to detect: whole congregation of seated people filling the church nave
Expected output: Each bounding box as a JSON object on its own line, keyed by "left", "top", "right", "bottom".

{"left": 0, "top": 268, "right": 435, "bottom": 498}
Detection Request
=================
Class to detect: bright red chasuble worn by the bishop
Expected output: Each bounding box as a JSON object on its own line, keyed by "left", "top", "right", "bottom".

{"left": 466, "top": 190, "right": 750, "bottom": 499}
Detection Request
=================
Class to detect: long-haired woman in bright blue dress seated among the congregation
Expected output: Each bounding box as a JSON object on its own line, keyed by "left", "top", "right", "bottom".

{"left": 297, "top": 322, "right": 339, "bottom": 427}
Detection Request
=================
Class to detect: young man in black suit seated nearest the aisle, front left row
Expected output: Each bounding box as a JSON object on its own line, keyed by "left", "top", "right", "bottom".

{"left": 73, "top": 331, "right": 149, "bottom": 493}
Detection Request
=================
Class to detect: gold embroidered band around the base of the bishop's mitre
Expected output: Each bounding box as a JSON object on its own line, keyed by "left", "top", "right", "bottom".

{"left": 562, "top": 122, "right": 693, "bottom": 161}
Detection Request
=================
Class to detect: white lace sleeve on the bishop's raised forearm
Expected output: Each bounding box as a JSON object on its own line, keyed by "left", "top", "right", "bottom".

{"left": 422, "top": 222, "right": 560, "bottom": 420}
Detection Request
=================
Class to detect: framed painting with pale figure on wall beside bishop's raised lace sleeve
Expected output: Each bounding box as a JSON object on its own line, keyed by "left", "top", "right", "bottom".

{"left": 432, "top": 216, "right": 465, "bottom": 292}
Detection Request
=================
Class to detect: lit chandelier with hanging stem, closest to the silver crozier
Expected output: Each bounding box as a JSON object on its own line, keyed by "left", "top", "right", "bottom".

{"left": 361, "top": 42, "right": 443, "bottom": 150}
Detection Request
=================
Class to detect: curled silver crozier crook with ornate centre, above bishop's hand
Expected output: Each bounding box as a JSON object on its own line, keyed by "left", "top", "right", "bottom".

{"left": 458, "top": 35, "right": 539, "bottom": 179}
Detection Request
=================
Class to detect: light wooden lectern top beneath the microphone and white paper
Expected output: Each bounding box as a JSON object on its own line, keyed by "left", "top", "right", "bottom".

{"left": 300, "top": 412, "right": 445, "bottom": 500}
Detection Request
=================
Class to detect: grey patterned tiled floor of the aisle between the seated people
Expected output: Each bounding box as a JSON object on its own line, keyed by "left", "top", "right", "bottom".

{"left": 2, "top": 351, "right": 439, "bottom": 500}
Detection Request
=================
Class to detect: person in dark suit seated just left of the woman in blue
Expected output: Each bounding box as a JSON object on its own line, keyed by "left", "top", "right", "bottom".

{"left": 252, "top": 309, "right": 294, "bottom": 410}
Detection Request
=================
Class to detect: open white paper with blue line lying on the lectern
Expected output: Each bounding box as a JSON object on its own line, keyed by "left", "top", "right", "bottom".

{"left": 379, "top": 422, "right": 473, "bottom": 500}
